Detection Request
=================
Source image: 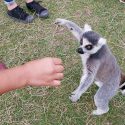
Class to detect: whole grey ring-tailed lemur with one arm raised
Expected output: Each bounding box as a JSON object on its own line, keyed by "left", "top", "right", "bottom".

{"left": 55, "top": 18, "right": 125, "bottom": 115}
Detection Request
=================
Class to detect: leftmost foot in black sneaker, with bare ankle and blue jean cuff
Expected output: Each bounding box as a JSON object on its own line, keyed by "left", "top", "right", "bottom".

{"left": 4, "top": 0, "right": 34, "bottom": 23}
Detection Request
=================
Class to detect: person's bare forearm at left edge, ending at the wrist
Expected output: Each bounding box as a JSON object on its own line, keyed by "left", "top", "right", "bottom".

{"left": 0, "top": 66, "right": 26, "bottom": 94}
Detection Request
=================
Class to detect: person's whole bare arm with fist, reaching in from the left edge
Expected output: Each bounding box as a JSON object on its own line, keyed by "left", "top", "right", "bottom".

{"left": 0, "top": 57, "right": 64, "bottom": 94}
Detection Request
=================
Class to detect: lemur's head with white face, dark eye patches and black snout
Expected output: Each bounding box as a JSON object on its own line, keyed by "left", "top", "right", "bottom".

{"left": 77, "top": 31, "right": 106, "bottom": 55}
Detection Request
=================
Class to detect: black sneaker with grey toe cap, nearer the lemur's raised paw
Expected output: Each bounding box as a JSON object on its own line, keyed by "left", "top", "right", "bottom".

{"left": 26, "top": 0, "right": 49, "bottom": 18}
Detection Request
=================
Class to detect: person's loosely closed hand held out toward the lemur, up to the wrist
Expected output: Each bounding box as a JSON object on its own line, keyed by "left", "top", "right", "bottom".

{"left": 23, "top": 57, "right": 64, "bottom": 86}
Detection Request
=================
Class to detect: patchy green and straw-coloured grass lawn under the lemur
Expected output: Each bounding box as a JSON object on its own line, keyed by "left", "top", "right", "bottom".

{"left": 0, "top": 0, "right": 125, "bottom": 125}
